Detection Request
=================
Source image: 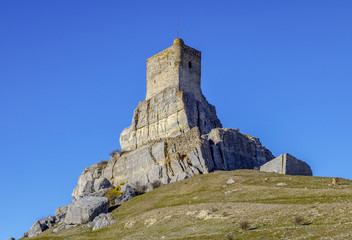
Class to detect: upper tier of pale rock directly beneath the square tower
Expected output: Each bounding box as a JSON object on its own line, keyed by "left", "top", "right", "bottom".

{"left": 120, "top": 88, "right": 221, "bottom": 151}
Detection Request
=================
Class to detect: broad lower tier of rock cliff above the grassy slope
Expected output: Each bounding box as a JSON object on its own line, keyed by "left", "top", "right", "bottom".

{"left": 73, "top": 127, "right": 274, "bottom": 198}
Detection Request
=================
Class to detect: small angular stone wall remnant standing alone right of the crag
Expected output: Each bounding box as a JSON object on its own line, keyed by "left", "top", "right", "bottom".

{"left": 260, "top": 153, "right": 313, "bottom": 176}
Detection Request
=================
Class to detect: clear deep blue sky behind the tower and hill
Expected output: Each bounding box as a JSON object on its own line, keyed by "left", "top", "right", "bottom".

{"left": 0, "top": 0, "right": 352, "bottom": 239}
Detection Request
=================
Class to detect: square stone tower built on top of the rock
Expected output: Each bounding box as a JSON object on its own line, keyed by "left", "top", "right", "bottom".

{"left": 146, "top": 38, "right": 203, "bottom": 101}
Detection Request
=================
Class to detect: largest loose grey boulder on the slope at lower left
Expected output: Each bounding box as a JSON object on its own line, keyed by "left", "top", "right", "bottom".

{"left": 65, "top": 196, "right": 109, "bottom": 224}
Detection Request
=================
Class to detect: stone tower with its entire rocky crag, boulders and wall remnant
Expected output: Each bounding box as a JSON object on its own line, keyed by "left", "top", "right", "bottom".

{"left": 26, "top": 38, "right": 312, "bottom": 237}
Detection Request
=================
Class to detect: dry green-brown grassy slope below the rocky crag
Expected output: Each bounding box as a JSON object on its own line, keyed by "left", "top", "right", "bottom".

{"left": 26, "top": 170, "right": 352, "bottom": 239}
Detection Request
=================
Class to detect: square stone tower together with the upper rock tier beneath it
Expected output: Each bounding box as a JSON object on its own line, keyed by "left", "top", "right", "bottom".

{"left": 120, "top": 38, "right": 222, "bottom": 151}
